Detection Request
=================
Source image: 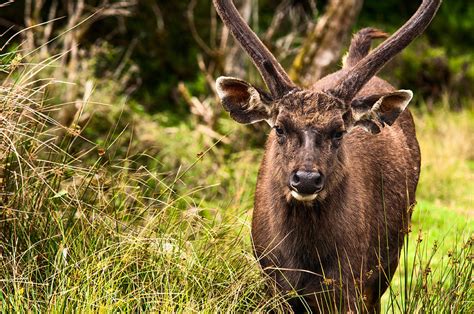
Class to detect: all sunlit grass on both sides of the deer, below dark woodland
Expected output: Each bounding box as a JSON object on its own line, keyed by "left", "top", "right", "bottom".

{"left": 0, "top": 52, "right": 474, "bottom": 313}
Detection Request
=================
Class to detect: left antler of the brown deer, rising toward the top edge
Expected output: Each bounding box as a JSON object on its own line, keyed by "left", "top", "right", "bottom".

{"left": 213, "top": 0, "right": 296, "bottom": 98}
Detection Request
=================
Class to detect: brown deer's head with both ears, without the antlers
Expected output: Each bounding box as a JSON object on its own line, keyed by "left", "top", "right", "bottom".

{"left": 217, "top": 77, "right": 412, "bottom": 202}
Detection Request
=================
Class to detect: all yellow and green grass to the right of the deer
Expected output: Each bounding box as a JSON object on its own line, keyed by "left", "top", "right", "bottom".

{"left": 382, "top": 106, "right": 474, "bottom": 313}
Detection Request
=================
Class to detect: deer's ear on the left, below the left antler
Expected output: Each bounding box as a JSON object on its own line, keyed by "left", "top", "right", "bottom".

{"left": 216, "top": 76, "right": 273, "bottom": 126}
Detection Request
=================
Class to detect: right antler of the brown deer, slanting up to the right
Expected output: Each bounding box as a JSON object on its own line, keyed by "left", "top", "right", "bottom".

{"left": 330, "top": 0, "right": 441, "bottom": 102}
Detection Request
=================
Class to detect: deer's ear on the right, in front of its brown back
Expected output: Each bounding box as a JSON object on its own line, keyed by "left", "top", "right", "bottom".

{"left": 351, "top": 89, "right": 413, "bottom": 134}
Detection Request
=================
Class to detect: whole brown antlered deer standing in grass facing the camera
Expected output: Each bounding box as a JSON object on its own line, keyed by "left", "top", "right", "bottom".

{"left": 214, "top": 0, "right": 441, "bottom": 312}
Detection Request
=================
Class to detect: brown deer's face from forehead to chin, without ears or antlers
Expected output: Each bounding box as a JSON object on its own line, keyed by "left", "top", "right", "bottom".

{"left": 271, "top": 91, "right": 347, "bottom": 202}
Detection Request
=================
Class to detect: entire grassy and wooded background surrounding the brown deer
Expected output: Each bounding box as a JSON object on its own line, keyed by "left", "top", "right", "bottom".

{"left": 0, "top": 0, "right": 474, "bottom": 312}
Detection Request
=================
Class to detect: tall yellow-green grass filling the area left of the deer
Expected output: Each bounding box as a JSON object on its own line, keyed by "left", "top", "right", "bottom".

{"left": 0, "top": 51, "right": 278, "bottom": 312}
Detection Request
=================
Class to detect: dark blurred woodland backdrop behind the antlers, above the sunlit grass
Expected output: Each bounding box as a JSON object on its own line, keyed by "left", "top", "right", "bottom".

{"left": 0, "top": 0, "right": 474, "bottom": 114}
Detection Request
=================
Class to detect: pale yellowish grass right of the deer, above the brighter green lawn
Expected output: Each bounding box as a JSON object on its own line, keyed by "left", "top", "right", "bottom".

{"left": 416, "top": 105, "right": 474, "bottom": 213}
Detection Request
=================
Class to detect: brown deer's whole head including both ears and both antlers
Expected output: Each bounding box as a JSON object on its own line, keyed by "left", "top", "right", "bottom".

{"left": 214, "top": 0, "right": 441, "bottom": 201}
